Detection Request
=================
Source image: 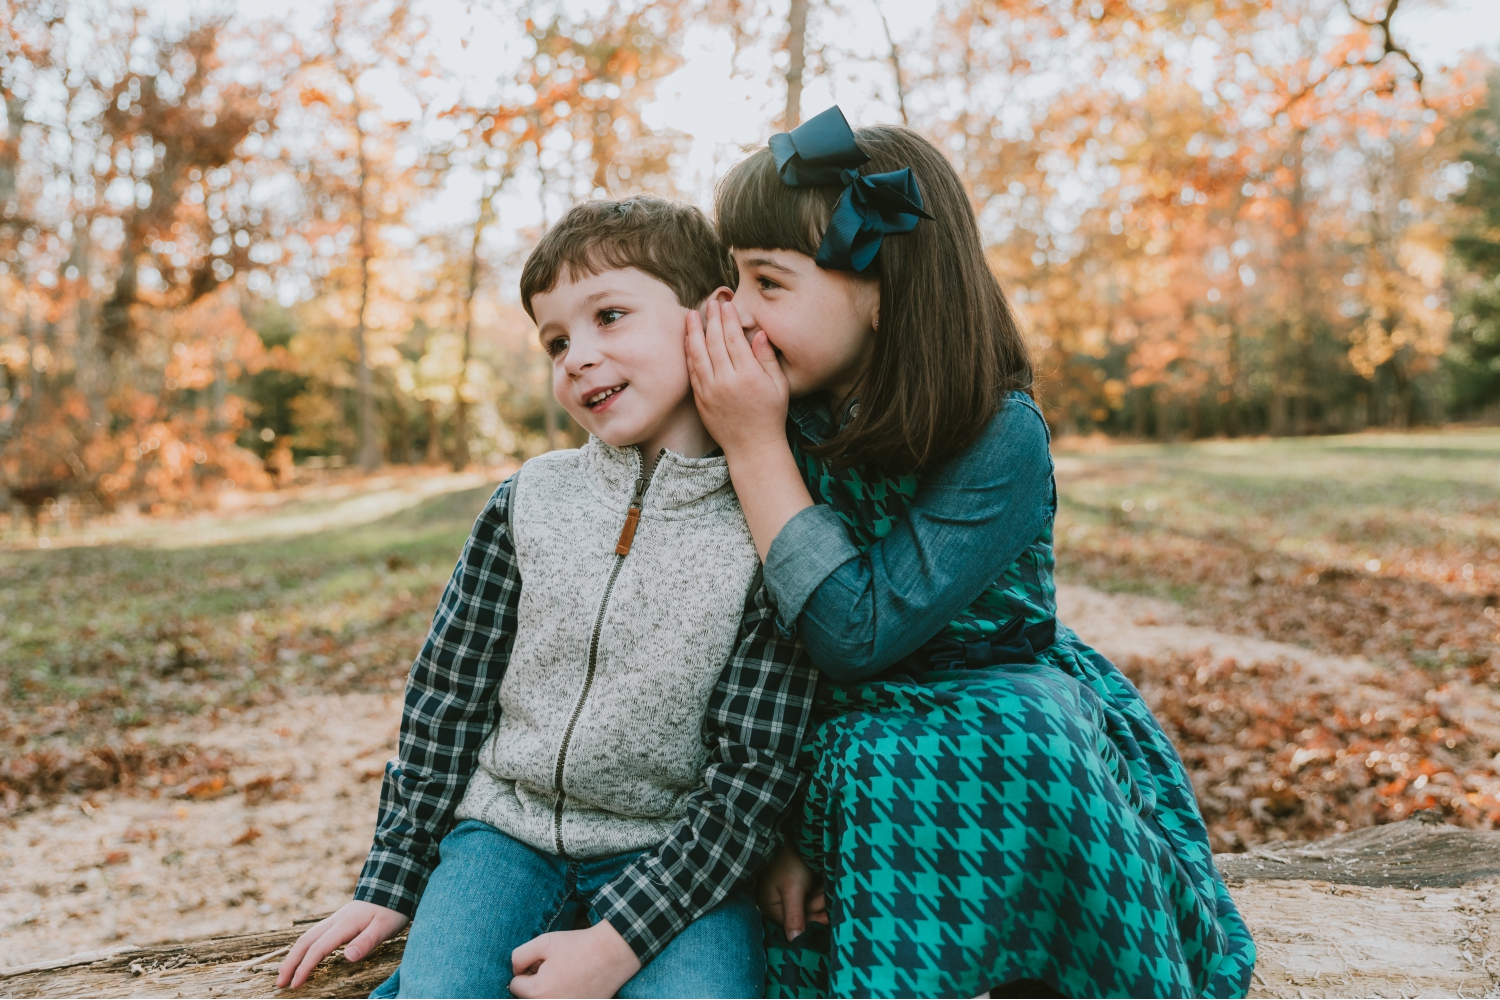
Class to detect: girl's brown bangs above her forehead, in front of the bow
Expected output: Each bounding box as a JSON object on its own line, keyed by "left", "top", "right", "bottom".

{"left": 714, "top": 148, "right": 839, "bottom": 256}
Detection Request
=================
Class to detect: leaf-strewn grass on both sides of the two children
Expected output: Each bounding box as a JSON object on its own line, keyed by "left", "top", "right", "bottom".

{"left": 0, "top": 430, "right": 1500, "bottom": 811}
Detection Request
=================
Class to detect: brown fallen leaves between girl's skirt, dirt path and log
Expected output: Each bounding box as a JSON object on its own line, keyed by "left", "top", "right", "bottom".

{"left": 1122, "top": 654, "right": 1500, "bottom": 852}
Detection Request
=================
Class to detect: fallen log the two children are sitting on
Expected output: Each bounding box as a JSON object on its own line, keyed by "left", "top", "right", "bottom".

{"left": 0, "top": 820, "right": 1500, "bottom": 997}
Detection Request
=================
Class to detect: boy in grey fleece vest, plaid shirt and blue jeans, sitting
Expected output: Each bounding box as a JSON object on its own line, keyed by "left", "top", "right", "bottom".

{"left": 278, "top": 198, "right": 815, "bottom": 997}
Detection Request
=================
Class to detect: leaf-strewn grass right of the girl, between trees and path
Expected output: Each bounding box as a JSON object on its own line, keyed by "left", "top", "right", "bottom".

{"left": 1058, "top": 429, "right": 1500, "bottom": 672}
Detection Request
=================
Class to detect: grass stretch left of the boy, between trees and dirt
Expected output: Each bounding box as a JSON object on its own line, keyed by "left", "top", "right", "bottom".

{"left": 0, "top": 484, "right": 494, "bottom": 756}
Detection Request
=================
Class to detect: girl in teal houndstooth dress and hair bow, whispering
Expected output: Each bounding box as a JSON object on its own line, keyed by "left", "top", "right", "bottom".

{"left": 687, "top": 108, "right": 1254, "bottom": 997}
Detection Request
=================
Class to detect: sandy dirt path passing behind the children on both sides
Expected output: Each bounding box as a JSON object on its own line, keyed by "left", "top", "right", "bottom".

{"left": 0, "top": 586, "right": 1370, "bottom": 969}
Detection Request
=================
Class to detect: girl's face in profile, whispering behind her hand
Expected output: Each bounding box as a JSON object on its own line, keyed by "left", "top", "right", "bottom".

{"left": 716, "top": 249, "right": 881, "bottom": 402}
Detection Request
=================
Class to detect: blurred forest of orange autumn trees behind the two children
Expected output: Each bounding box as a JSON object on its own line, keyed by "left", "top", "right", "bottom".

{"left": 0, "top": 0, "right": 1500, "bottom": 515}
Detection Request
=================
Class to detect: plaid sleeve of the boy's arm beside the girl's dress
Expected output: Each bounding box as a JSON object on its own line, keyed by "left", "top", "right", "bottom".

{"left": 594, "top": 586, "right": 818, "bottom": 966}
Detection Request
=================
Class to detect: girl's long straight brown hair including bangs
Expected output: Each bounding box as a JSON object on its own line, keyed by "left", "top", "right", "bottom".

{"left": 716, "top": 126, "right": 1032, "bottom": 474}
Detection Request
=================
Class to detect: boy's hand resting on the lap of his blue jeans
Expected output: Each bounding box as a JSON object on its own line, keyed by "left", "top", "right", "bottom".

{"left": 510, "top": 921, "right": 641, "bottom": 997}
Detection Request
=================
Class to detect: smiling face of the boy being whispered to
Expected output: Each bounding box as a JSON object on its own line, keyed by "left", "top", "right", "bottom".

{"left": 531, "top": 267, "right": 698, "bottom": 448}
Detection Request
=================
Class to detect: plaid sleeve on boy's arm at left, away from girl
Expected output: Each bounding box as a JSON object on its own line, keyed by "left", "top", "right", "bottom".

{"left": 354, "top": 477, "right": 521, "bottom": 916}
